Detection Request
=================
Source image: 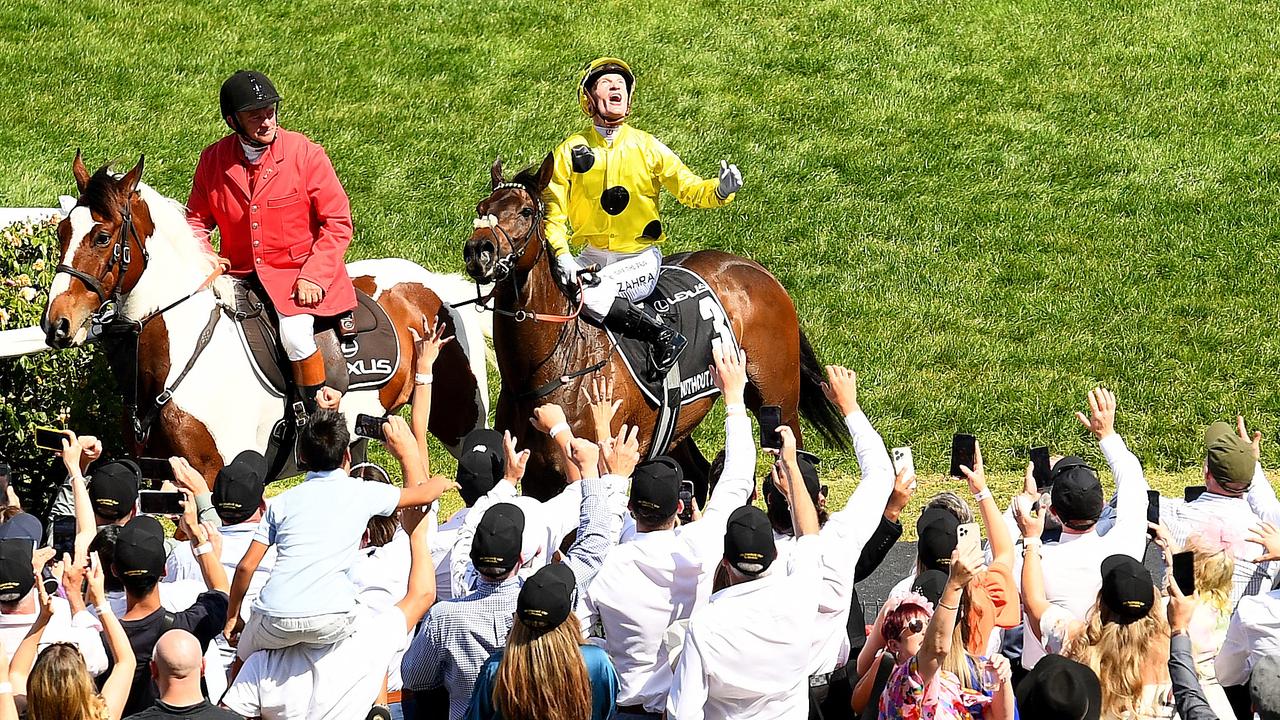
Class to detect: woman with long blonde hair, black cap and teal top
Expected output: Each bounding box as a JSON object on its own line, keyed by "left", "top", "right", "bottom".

{"left": 466, "top": 562, "right": 618, "bottom": 720}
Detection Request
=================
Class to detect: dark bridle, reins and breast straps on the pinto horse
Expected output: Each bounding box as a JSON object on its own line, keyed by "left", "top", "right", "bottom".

{"left": 54, "top": 193, "right": 229, "bottom": 450}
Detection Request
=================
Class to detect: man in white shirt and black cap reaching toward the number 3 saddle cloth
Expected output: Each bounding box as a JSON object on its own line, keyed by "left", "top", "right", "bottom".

{"left": 584, "top": 347, "right": 755, "bottom": 720}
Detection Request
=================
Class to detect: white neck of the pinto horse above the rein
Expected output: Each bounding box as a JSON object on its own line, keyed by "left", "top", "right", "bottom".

{"left": 124, "top": 188, "right": 215, "bottom": 320}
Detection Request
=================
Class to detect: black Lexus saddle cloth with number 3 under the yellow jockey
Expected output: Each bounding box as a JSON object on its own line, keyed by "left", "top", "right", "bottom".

{"left": 605, "top": 262, "right": 739, "bottom": 456}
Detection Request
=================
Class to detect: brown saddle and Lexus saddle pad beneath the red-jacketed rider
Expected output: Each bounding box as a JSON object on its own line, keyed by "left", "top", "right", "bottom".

{"left": 236, "top": 281, "right": 401, "bottom": 397}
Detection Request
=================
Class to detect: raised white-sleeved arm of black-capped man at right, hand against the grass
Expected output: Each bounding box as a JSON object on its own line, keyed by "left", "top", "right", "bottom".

{"left": 1075, "top": 387, "right": 1149, "bottom": 543}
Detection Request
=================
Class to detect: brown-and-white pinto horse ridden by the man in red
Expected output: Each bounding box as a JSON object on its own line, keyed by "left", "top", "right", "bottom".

{"left": 41, "top": 152, "right": 488, "bottom": 484}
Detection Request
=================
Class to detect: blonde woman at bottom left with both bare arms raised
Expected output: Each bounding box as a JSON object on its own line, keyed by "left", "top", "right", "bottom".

{"left": 10, "top": 555, "right": 137, "bottom": 720}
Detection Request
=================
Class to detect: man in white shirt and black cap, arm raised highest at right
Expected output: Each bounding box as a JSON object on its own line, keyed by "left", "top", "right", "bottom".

{"left": 1023, "top": 387, "right": 1149, "bottom": 670}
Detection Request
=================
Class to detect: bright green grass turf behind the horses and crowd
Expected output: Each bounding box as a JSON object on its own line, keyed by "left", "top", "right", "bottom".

{"left": 0, "top": 0, "right": 1280, "bottom": 527}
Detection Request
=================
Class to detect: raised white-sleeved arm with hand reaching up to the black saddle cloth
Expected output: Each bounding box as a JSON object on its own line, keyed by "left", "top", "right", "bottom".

{"left": 700, "top": 345, "right": 755, "bottom": 517}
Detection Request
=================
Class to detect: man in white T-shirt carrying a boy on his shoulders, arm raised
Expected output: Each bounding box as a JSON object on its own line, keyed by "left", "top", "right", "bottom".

{"left": 223, "top": 499, "right": 435, "bottom": 720}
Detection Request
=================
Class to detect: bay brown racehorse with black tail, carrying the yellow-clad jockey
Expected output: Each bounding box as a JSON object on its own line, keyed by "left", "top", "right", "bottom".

{"left": 463, "top": 155, "right": 847, "bottom": 498}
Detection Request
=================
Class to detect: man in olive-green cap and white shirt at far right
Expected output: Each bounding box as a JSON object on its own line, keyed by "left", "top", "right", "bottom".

{"left": 1161, "top": 418, "right": 1280, "bottom": 607}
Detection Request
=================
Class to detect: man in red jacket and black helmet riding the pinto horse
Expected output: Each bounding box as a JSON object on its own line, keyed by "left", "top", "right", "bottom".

{"left": 187, "top": 70, "right": 356, "bottom": 411}
